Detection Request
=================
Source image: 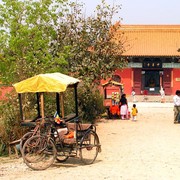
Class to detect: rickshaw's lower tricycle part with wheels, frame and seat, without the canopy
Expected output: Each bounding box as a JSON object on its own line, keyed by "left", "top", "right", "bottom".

{"left": 22, "top": 118, "right": 101, "bottom": 170}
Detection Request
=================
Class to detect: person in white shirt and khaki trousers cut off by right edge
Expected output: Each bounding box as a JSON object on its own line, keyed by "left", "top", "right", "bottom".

{"left": 173, "top": 90, "right": 180, "bottom": 124}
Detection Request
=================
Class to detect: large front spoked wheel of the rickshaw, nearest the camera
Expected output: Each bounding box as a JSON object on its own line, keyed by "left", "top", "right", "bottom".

{"left": 22, "top": 136, "right": 57, "bottom": 170}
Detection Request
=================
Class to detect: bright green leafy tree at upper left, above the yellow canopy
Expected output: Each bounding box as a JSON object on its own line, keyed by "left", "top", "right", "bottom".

{"left": 0, "top": 0, "right": 67, "bottom": 83}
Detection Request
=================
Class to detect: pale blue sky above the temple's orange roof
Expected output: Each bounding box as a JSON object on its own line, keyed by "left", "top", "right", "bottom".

{"left": 82, "top": 0, "right": 180, "bottom": 25}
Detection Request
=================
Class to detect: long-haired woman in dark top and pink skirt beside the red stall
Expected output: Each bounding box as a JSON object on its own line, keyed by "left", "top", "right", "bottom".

{"left": 120, "top": 94, "right": 128, "bottom": 119}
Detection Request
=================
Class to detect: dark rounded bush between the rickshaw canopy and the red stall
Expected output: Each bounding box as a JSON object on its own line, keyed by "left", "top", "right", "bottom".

{"left": 78, "top": 86, "right": 105, "bottom": 123}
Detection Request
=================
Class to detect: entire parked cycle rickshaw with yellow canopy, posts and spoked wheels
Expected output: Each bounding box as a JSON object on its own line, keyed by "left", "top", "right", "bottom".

{"left": 13, "top": 73, "right": 101, "bottom": 170}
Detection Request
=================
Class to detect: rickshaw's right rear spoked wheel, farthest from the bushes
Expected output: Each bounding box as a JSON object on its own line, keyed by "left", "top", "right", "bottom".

{"left": 80, "top": 131, "right": 99, "bottom": 164}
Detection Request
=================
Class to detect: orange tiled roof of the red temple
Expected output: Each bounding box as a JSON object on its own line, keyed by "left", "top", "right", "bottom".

{"left": 119, "top": 25, "right": 180, "bottom": 56}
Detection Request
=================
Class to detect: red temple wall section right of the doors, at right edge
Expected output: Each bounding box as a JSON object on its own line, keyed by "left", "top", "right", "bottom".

{"left": 172, "top": 69, "right": 180, "bottom": 94}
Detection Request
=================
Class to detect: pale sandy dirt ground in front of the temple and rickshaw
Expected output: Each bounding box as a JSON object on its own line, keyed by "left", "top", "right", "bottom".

{"left": 0, "top": 102, "right": 180, "bottom": 180}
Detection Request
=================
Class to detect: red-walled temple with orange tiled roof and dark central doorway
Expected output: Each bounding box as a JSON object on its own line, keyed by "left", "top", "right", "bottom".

{"left": 112, "top": 25, "right": 180, "bottom": 95}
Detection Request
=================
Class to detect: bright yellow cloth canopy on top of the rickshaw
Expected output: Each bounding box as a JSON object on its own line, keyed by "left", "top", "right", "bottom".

{"left": 13, "top": 73, "right": 80, "bottom": 93}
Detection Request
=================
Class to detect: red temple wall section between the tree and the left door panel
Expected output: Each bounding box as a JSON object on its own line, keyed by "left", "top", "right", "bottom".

{"left": 115, "top": 68, "right": 133, "bottom": 95}
